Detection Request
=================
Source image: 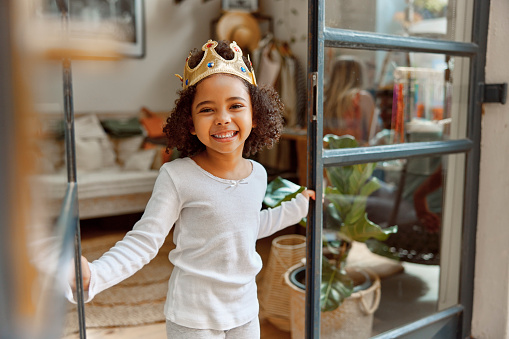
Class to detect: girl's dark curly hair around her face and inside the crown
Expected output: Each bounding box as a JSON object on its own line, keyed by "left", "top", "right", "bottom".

{"left": 163, "top": 40, "right": 284, "bottom": 157}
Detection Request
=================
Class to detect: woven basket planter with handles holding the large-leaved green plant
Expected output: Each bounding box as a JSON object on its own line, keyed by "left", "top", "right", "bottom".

{"left": 285, "top": 264, "right": 381, "bottom": 339}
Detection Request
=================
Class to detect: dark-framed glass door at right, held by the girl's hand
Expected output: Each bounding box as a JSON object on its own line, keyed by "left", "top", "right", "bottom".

{"left": 306, "top": 0, "right": 489, "bottom": 338}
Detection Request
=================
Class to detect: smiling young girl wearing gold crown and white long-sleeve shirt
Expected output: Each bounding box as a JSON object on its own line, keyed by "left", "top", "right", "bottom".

{"left": 67, "top": 40, "right": 315, "bottom": 339}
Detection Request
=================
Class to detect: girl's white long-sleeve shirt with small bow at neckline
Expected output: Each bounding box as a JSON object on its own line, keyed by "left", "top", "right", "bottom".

{"left": 68, "top": 158, "right": 308, "bottom": 330}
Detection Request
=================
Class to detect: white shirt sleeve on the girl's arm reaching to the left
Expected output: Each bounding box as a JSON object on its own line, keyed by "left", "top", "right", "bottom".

{"left": 66, "top": 168, "right": 181, "bottom": 302}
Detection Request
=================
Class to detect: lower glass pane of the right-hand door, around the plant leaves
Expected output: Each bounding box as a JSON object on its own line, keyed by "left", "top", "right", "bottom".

{"left": 324, "top": 153, "right": 450, "bottom": 335}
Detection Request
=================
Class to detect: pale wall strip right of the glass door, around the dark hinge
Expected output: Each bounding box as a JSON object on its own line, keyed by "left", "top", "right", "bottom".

{"left": 472, "top": 0, "right": 509, "bottom": 339}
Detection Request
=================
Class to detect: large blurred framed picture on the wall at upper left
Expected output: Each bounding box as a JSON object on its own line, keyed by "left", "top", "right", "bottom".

{"left": 36, "top": 0, "right": 145, "bottom": 58}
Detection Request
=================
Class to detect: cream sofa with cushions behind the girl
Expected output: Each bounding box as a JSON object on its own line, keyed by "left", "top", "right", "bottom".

{"left": 31, "top": 109, "right": 178, "bottom": 219}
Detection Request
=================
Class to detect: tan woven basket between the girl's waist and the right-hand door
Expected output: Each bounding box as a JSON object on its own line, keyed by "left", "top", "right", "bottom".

{"left": 260, "top": 234, "right": 306, "bottom": 332}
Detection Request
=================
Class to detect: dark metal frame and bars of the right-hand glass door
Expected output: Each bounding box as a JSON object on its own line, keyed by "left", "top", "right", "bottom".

{"left": 306, "top": 0, "right": 490, "bottom": 339}
